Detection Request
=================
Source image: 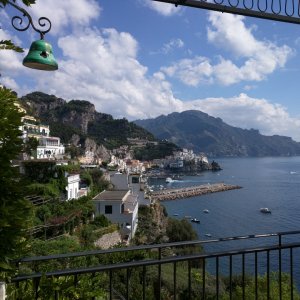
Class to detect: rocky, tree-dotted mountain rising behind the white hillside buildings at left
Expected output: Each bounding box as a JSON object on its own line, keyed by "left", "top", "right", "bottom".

{"left": 20, "top": 92, "right": 155, "bottom": 149}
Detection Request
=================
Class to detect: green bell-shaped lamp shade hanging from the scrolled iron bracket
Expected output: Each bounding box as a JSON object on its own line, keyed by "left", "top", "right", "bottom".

{"left": 23, "top": 40, "right": 58, "bottom": 71}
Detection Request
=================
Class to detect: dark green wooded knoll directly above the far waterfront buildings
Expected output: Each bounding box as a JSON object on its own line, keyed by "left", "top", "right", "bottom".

{"left": 134, "top": 141, "right": 179, "bottom": 161}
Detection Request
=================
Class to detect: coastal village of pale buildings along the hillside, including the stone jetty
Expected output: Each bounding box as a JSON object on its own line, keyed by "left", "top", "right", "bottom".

{"left": 15, "top": 106, "right": 231, "bottom": 248}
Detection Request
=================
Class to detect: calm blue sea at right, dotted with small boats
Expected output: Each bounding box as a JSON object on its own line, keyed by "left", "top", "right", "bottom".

{"left": 150, "top": 157, "right": 300, "bottom": 289}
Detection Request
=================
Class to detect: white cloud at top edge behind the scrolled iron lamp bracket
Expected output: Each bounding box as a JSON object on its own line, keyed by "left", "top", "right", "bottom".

{"left": 29, "top": 0, "right": 101, "bottom": 35}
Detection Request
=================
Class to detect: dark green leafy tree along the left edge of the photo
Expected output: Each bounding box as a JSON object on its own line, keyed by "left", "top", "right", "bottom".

{"left": 0, "top": 87, "right": 31, "bottom": 277}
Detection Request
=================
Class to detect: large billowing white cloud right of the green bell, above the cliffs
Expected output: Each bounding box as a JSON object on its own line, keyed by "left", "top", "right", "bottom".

{"left": 28, "top": 29, "right": 180, "bottom": 119}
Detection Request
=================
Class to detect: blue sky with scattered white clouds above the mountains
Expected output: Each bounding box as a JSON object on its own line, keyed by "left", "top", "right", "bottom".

{"left": 0, "top": 0, "right": 300, "bottom": 142}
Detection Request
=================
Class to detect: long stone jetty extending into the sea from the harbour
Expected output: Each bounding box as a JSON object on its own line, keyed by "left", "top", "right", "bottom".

{"left": 149, "top": 183, "right": 242, "bottom": 201}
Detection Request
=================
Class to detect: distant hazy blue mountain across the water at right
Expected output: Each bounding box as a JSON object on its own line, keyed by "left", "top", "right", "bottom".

{"left": 135, "top": 110, "right": 300, "bottom": 157}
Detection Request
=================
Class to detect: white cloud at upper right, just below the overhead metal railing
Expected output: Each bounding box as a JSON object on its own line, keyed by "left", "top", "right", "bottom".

{"left": 162, "top": 12, "right": 293, "bottom": 86}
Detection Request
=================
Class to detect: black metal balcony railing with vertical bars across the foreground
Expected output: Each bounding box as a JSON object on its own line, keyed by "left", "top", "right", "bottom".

{"left": 10, "top": 231, "right": 300, "bottom": 300}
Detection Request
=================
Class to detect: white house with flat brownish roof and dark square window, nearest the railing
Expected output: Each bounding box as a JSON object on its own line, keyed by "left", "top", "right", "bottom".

{"left": 93, "top": 189, "right": 138, "bottom": 241}
